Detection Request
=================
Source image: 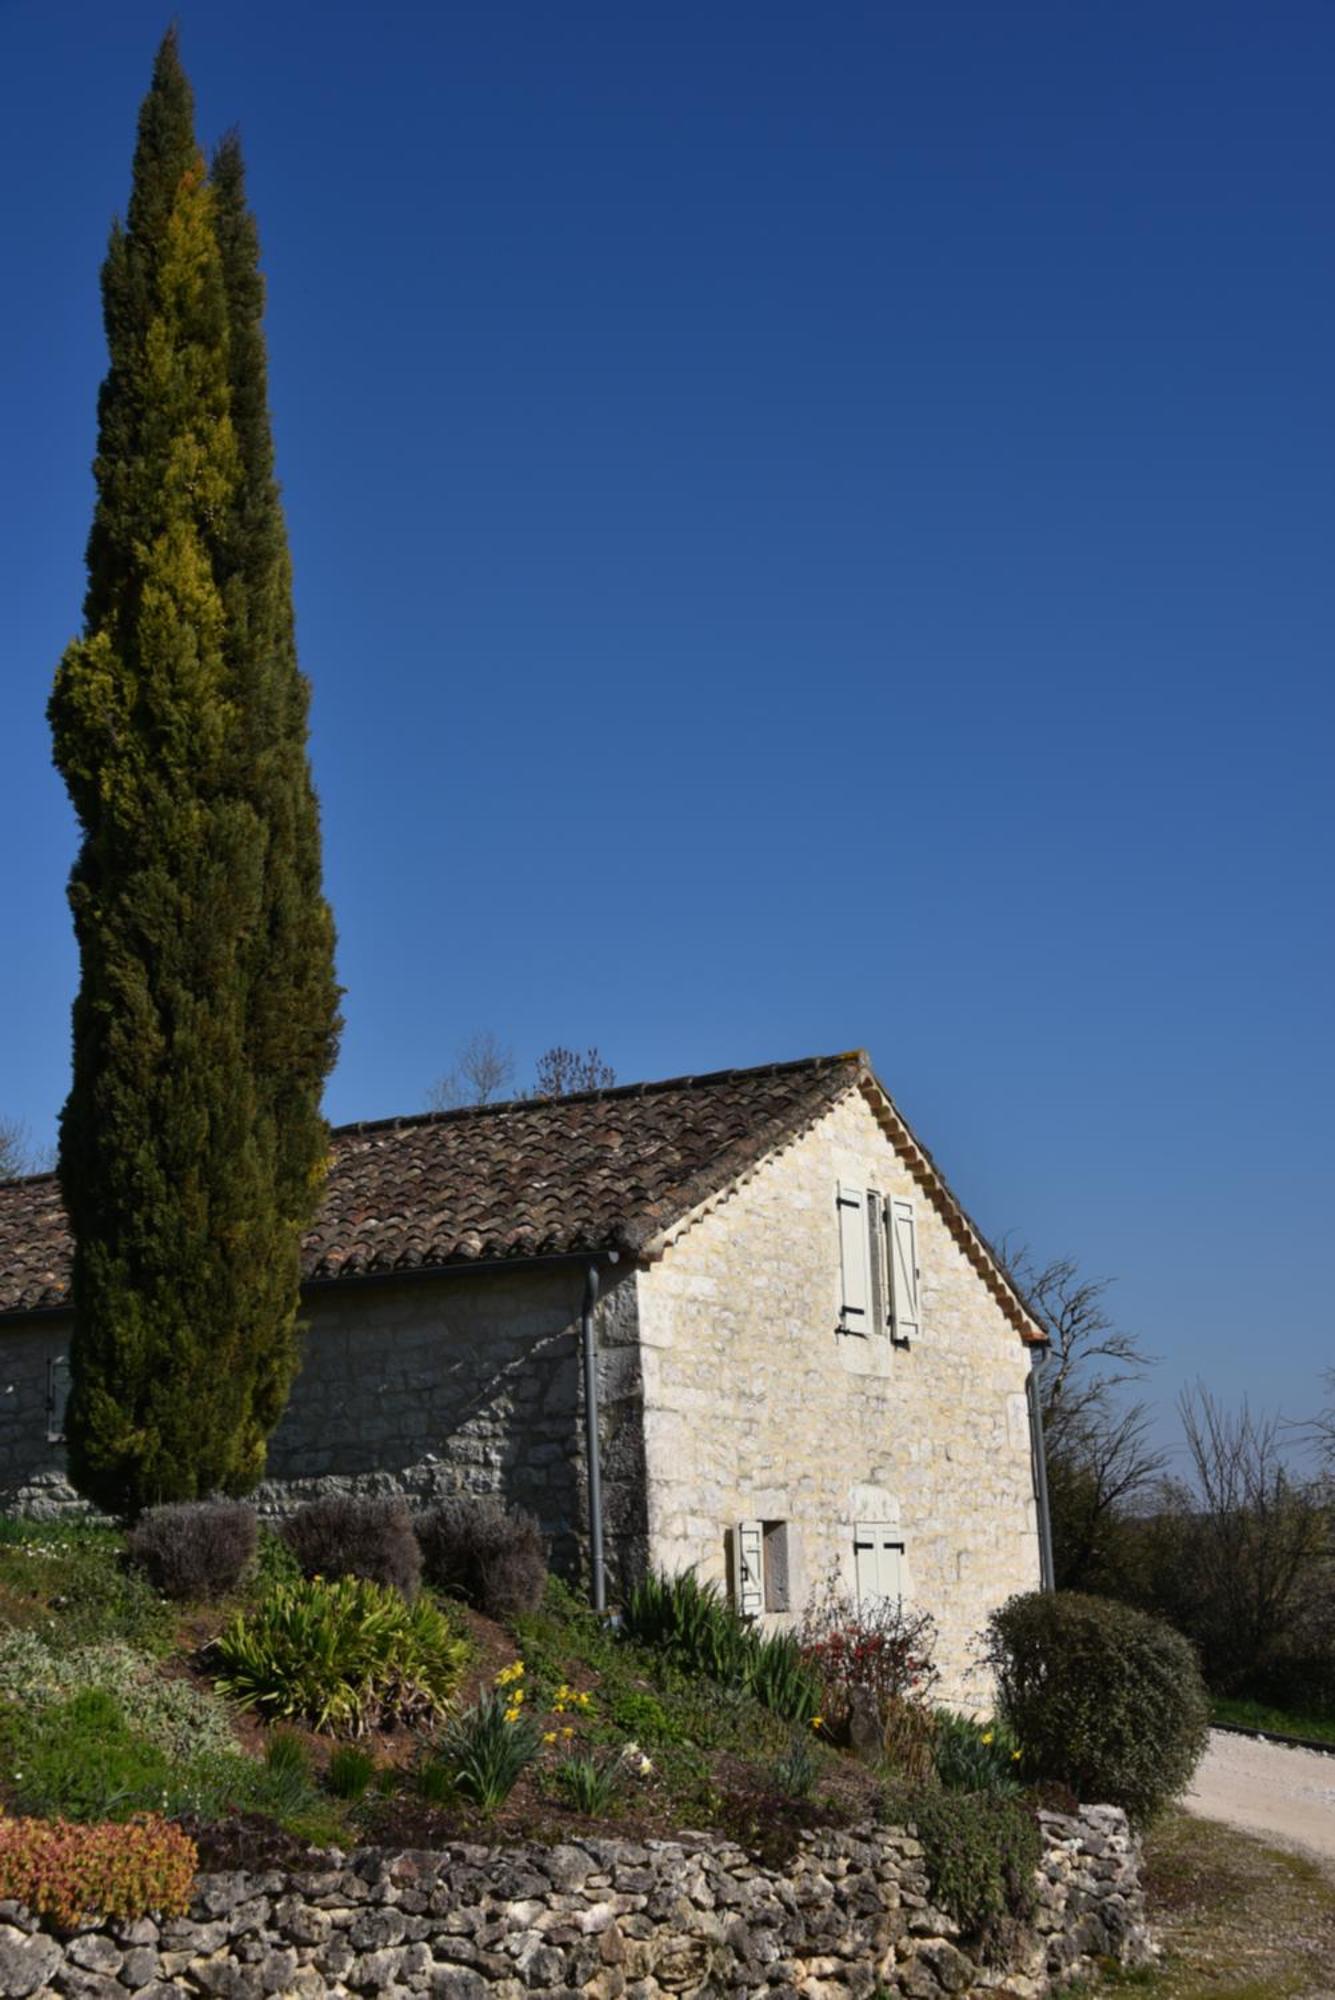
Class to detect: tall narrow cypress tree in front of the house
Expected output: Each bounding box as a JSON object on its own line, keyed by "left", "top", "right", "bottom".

{"left": 50, "top": 34, "right": 338, "bottom": 1512}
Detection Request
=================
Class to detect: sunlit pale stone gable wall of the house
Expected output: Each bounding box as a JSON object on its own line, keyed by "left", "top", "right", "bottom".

{"left": 640, "top": 1092, "right": 1039, "bottom": 1706}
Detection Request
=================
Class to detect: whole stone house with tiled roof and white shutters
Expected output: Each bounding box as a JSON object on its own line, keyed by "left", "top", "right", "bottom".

{"left": 0, "top": 1052, "right": 1043, "bottom": 1694}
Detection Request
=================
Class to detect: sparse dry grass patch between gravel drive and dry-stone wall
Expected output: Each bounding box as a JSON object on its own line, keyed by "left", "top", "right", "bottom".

{"left": 1067, "top": 1812, "right": 1335, "bottom": 2000}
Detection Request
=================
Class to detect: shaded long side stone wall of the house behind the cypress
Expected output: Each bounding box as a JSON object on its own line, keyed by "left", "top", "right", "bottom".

{"left": 0, "top": 1266, "right": 646, "bottom": 1574}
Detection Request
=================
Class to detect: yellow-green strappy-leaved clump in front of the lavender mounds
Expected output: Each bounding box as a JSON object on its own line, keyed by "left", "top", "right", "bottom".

{"left": 214, "top": 1576, "right": 468, "bottom": 1736}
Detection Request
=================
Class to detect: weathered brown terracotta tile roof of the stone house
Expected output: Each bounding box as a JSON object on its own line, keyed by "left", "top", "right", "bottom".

{"left": 0, "top": 1050, "right": 1037, "bottom": 1338}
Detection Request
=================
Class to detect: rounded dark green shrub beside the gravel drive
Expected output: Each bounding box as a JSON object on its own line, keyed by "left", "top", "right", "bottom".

{"left": 987, "top": 1590, "right": 1209, "bottom": 1824}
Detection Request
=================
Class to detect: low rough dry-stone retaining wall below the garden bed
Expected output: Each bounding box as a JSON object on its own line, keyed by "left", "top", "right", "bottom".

{"left": 0, "top": 1806, "right": 1151, "bottom": 2000}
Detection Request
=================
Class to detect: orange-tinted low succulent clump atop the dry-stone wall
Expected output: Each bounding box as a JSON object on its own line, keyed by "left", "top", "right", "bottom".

{"left": 0, "top": 1814, "right": 198, "bottom": 1930}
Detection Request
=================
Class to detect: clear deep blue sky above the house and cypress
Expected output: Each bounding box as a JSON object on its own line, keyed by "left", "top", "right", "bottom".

{"left": 0, "top": 0, "right": 1335, "bottom": 1440}
